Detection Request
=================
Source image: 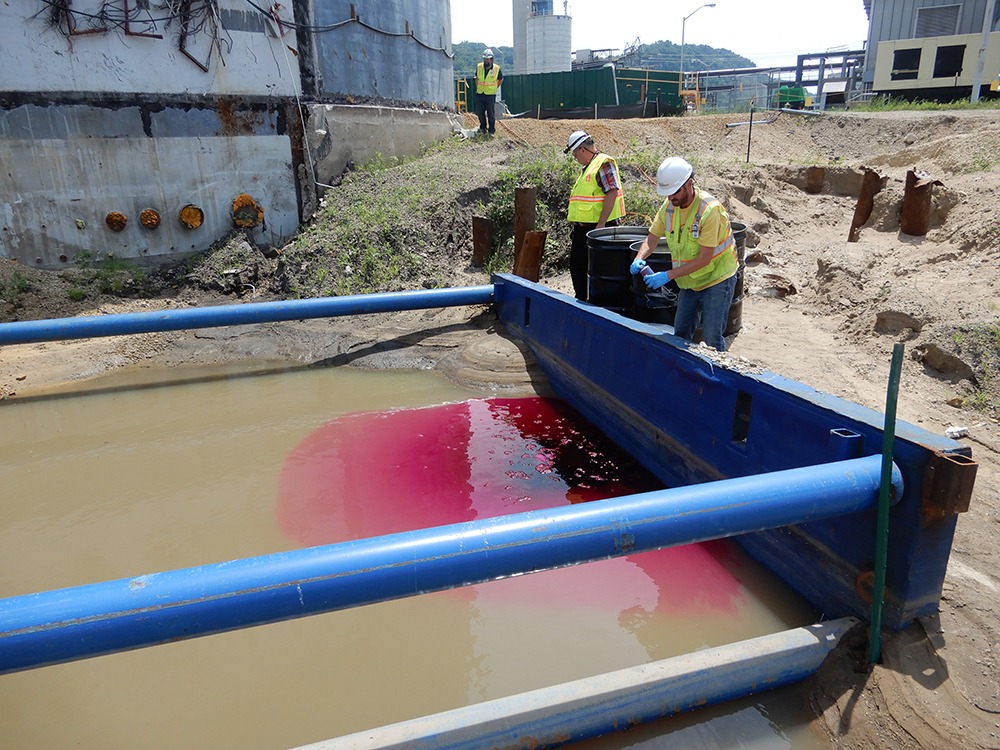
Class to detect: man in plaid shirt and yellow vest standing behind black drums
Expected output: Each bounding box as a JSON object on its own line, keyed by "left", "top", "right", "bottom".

{"left": 563, "top": 130, "right": 625, "bottom": 300}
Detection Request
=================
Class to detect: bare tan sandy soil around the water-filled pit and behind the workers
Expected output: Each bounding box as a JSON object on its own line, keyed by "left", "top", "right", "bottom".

{"left": 0, "top": 111, "right": 1000, "bottom": 748}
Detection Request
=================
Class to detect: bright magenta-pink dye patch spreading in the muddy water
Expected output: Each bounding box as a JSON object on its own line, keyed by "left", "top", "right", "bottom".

{"left": 278, "top": 398, "right": 743, "bottom": 614}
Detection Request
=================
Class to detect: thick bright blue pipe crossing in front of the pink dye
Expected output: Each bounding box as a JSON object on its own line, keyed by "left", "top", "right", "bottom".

{"left": 0, "top": 456, "right": 902, "bottom": 674}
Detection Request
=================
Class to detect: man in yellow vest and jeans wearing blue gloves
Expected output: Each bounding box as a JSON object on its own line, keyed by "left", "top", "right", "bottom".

{"left": 629, "top": 156, "right": 739, "bottom": 352}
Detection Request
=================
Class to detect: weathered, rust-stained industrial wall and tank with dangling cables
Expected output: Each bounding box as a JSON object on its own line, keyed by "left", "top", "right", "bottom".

{"left": 0, "top": 0, "right": 452, "bottom": 268}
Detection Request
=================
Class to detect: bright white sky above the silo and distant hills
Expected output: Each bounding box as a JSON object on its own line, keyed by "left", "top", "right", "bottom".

{"left": 451, "top": 0, "right": 868, "bottom": 66}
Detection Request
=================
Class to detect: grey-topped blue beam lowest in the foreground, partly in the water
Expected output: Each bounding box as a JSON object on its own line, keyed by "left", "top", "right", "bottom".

{"left": 297, "top": 617, "right": 859, "bottom": 750}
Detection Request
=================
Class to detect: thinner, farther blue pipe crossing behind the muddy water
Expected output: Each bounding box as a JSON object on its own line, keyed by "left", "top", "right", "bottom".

{"left": 0, "top": 284, "right": 494, "bottom": 345}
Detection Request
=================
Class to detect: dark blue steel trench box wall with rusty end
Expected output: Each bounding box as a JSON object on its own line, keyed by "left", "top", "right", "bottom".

{"left": 493, "top": 275, "right": 976, "bottom": 629}
